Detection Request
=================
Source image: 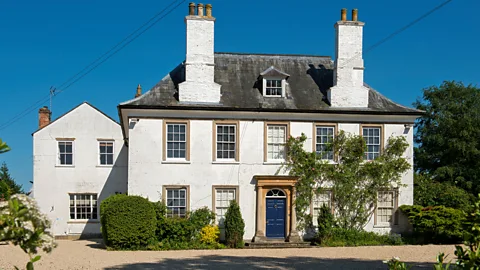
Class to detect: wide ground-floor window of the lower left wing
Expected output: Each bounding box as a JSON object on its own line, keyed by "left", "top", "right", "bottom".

{"left": 70, "top": 194, "right": 98, "bottom": 220}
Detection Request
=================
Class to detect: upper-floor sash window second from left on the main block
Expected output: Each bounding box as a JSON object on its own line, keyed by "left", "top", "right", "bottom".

{"left": 214, "top": 123, "right": 238, "bottom": 161}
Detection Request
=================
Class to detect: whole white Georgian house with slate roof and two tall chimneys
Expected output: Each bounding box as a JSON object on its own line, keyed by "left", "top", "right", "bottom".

{"left": 33, "top": 3, "right": 422, "bottom": 241}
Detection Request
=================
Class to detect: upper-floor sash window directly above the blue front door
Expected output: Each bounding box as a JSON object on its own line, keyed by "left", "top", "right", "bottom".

{"left": 265, "top": 124, "right": 288, "bottom": 161}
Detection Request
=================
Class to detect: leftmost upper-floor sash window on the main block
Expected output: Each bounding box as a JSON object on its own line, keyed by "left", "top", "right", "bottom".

{"left": 163, "top": 121, "right": 189, "bottom": 160}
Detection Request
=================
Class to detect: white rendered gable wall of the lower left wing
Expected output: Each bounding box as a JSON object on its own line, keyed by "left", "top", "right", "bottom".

{"left": 33, "top": 103, "right": 128, "bottom": 236}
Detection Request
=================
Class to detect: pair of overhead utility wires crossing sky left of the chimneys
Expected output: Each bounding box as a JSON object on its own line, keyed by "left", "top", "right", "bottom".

{"left": 0, "top": 0, "right": 186, "bottom": 130}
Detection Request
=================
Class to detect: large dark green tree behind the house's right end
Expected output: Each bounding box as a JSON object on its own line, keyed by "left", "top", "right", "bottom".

{"left": 414, "top": 81, "right": 480, "bottom": 194}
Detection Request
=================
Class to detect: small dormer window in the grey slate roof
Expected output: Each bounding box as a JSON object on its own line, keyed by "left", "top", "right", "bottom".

{"left": 259, "top": 66, "right": 290, "bottom": 97}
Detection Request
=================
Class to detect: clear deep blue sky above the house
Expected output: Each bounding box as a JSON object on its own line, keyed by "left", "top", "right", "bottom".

{"left": 0, "top": 0, "right": 480, "bottom": 190}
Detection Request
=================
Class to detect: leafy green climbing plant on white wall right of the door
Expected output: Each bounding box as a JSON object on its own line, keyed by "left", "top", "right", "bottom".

{"left": 284, "top": 131, "right": 410, "bottom": 230}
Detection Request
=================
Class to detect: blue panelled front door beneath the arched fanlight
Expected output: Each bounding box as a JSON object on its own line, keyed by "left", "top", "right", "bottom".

{"left": 266, "top": 198, "right": 285, "bottom": 238}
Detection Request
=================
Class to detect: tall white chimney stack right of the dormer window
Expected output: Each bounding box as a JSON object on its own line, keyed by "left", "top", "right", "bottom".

{"left": 328, "top": 9, "right": 369, "bottom": 108}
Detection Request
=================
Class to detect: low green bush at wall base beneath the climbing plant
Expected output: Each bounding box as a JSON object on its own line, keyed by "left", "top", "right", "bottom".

{"left": 321, "top": 228, "right": 403, "bottom": 247}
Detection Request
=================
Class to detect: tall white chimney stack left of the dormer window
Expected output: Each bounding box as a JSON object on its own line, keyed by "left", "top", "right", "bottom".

{"left": 179, "top": 3, "right": 221, "bottom": 103}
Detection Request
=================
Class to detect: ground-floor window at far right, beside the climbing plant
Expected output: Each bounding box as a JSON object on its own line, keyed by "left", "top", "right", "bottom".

{"left": 375, "top": 190, "right": 397, "bottom": 226}
